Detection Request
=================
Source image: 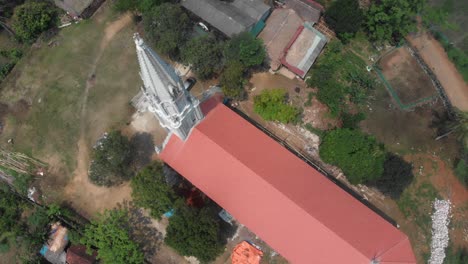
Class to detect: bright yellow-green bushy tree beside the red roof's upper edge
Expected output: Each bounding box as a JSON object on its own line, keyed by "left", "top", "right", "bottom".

{"left": 254, "top": 89, "right": 301, "bottom": 124}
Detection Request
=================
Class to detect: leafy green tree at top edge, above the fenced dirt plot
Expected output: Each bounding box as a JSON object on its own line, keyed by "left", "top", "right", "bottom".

{"left": 366, "top": 0, "right": 424, "bottom": 42}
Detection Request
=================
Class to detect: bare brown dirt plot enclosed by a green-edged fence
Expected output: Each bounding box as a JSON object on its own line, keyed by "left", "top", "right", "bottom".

{"left": 379, "top": 47, "right": 437, "bottom": 105}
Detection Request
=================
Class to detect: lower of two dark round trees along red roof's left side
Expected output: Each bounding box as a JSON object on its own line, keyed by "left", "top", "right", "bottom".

{"left": 165, "top": 202, "right": 223, "bottom": 262}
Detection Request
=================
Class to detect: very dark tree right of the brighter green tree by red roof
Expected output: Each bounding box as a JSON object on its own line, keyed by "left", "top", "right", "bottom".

{"left": 374, "top": 154, "right": 414, "bottom": 199}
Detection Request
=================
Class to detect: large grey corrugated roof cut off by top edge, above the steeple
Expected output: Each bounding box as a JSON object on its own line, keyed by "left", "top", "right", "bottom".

{"left": 181, "top": 0, "right": 270, "bottom": 37}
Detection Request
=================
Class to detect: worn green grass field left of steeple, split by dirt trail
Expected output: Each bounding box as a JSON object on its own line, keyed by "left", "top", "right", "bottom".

{"left": 0, "top": 8, "right": 139, "bottom": 191}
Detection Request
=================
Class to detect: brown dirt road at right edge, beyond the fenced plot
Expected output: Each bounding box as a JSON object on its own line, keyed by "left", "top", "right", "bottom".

{"left": 407, "top": 32, "right": 468, "bottom": 111}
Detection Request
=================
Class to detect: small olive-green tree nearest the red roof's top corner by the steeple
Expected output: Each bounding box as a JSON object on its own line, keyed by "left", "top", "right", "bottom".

{"left": 220, "top": 61, "right": 246, "bottom": 100}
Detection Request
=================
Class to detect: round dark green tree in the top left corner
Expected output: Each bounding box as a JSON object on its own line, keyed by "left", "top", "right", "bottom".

{"left": 12, "top": 1, "right": 58, "bottom": 42}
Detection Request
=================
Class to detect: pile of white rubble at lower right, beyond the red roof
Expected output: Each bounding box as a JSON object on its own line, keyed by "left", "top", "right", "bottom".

{"left": 429, "top": 199, "right": 451, "bottom": 264}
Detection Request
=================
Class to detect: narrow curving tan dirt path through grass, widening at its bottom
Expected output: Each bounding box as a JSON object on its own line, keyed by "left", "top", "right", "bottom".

{"left": 64, "top": 14, "right": 131, "bottom": 218}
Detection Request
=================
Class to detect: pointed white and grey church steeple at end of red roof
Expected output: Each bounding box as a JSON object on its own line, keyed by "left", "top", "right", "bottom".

{"left": 133, "top": 34, "right": 203, "bottom": 140}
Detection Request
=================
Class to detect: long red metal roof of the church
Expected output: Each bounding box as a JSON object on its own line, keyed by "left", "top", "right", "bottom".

{"left": 160, "top": 100, "right": 416, "bottom": 264}
